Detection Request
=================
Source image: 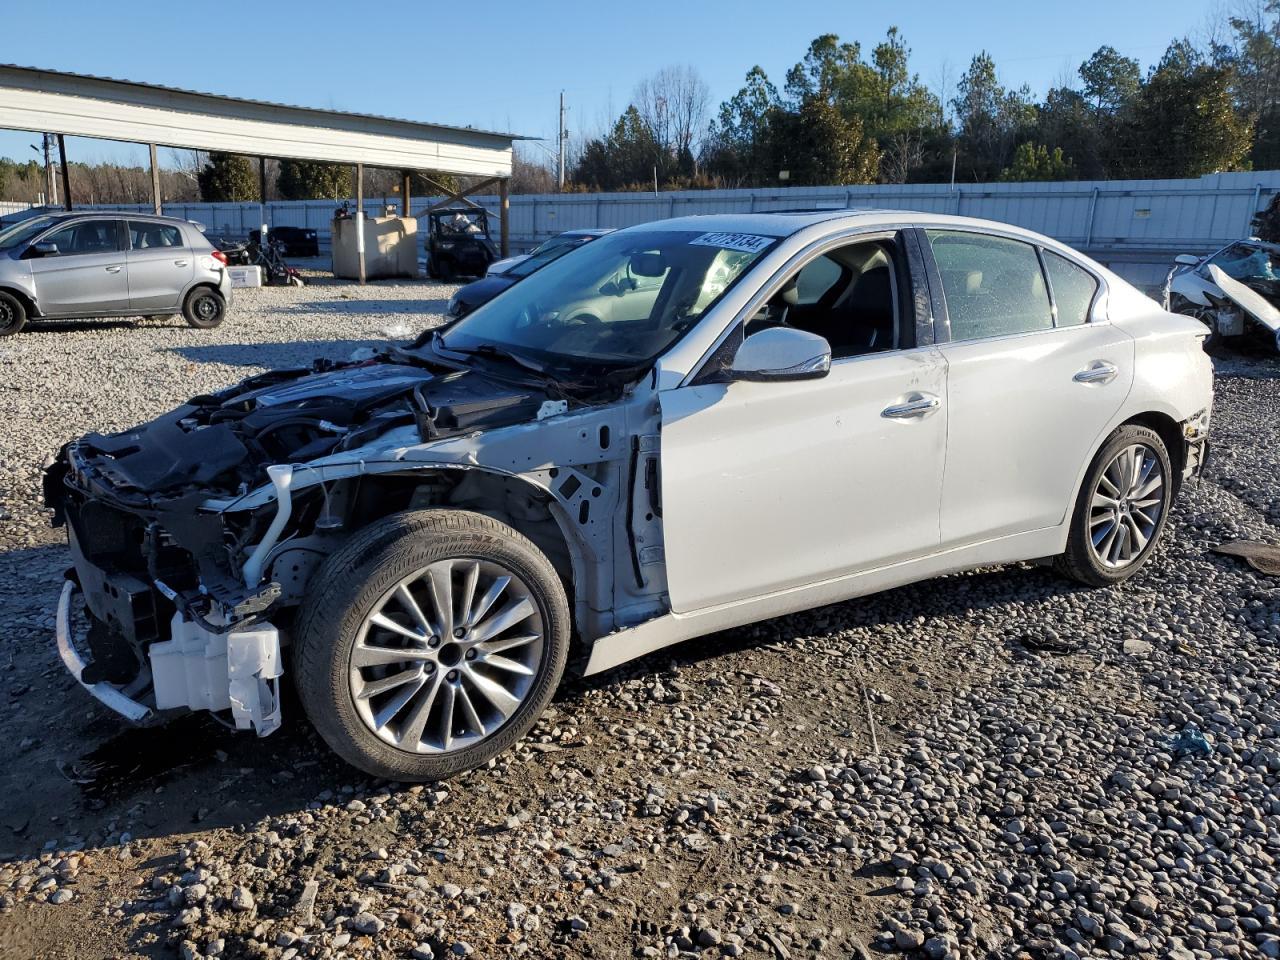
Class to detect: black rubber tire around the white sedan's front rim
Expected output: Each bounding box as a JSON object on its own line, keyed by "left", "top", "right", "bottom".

{"left": 294, "top": 511, "right": 570, "bottom": 781}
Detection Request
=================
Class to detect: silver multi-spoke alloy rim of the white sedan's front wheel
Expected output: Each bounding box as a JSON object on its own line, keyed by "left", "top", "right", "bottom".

{"left": 348, "top": 559, "right": 545, "bottom": 754}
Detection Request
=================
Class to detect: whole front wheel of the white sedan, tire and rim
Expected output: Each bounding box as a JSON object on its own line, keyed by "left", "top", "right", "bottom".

{"left": 294, "top": 509, "right": 570, "bottom": 781}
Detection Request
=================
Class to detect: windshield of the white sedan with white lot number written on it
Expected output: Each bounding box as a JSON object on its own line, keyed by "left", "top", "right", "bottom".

{"left": 439, "top": 230, "right": 777, "bottom": 367}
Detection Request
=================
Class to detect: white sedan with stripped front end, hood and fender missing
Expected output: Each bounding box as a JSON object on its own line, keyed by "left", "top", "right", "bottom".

{"left": 46, "top": 211, "right": 1212, "bottom": 781}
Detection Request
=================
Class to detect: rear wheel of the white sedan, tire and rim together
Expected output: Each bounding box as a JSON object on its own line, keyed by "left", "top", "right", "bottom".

{"left": 1053, "top": 424, "right": 1174, "bottom": 586}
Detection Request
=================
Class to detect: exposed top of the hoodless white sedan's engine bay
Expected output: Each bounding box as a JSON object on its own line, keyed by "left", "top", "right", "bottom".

{"left": 46, "top": 356, "right": 550, "bottom": 507}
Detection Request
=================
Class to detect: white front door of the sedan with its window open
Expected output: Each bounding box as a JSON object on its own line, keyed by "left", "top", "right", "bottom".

{"left": 660, "top": 232, "right": 947, "bottom": 613}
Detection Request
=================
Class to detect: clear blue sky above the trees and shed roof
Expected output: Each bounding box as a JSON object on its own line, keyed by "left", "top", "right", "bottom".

{"left": 0, "top": 0, "right": 1216, "bottom": 164}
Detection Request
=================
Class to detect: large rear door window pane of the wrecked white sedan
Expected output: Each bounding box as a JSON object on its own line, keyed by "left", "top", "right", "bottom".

{"left": 927, "top": 230, "right": 1053, "bottom": 340}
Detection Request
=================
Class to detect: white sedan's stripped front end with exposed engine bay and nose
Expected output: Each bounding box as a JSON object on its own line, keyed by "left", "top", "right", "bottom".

{"left": 45, "top": 356, "right": 576, "bottom": 735}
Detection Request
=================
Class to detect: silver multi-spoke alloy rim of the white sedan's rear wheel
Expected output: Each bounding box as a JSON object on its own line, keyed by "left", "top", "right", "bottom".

{"left": 1089, "top": 443, "right": 1165, "bottom": 570}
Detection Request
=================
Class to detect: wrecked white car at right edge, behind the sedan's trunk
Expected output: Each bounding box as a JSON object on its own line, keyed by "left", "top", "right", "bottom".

{"left": 1165, "top": 239, "right": 1280, "bottom": 353}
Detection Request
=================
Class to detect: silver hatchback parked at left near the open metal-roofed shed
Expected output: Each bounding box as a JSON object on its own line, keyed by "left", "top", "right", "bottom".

{"left": 0, "top": 212, "right": 232, "bottom": 337}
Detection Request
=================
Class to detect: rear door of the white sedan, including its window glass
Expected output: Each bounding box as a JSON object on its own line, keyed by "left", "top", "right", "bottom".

{"left": 923, "top": 229, "right": 1134, "bottom": 548}
